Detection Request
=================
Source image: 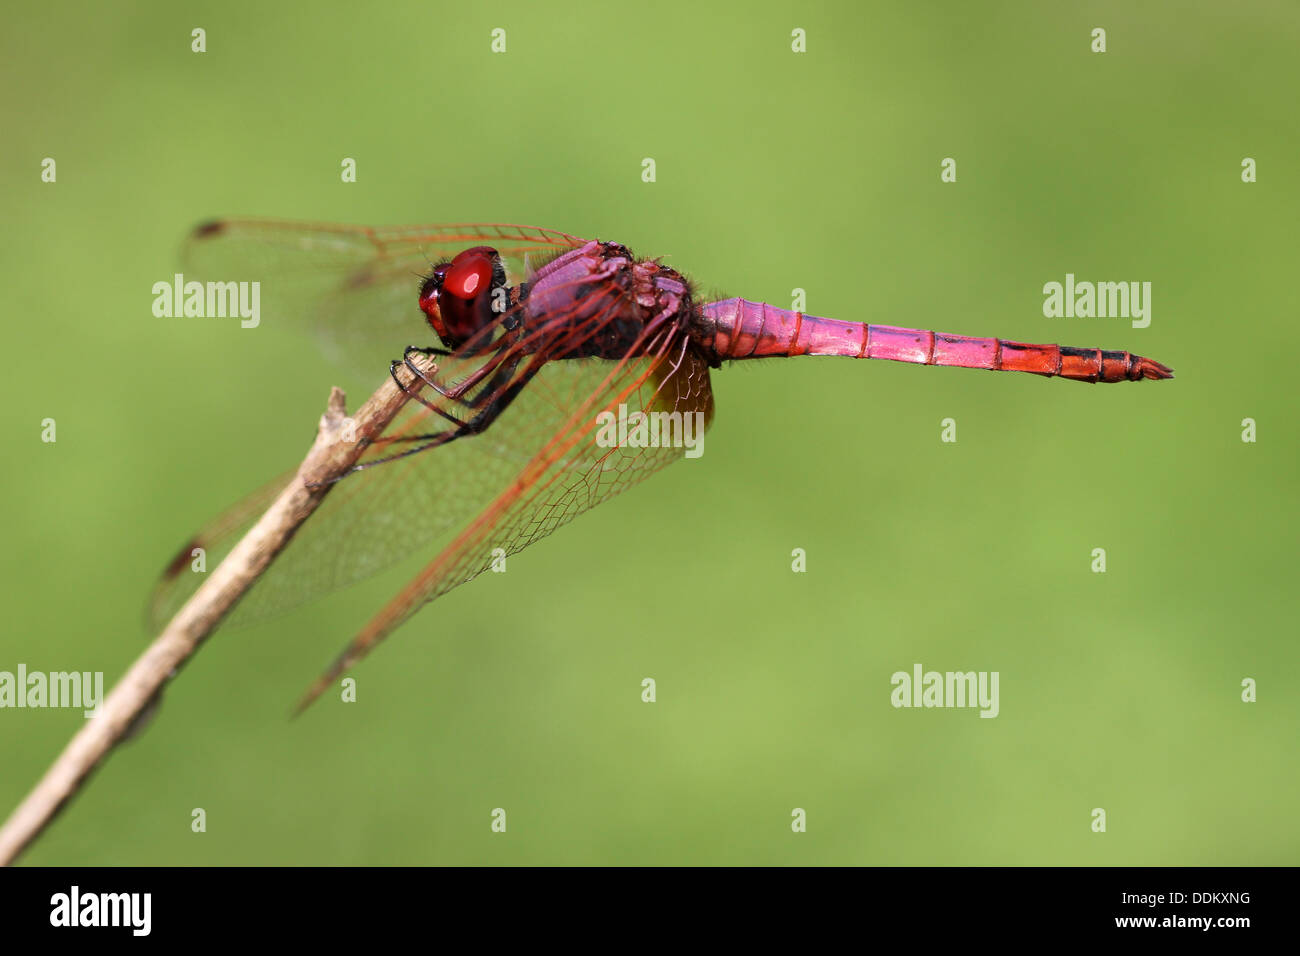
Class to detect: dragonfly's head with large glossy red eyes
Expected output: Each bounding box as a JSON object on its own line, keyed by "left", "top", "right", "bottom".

{"left": 420, "top": 246, "right": 510, "bottom": 350}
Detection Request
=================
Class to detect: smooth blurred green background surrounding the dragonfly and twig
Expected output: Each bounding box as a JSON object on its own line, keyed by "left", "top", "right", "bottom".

{"left": 0, "top": 0, "right": 1300, "bottom": 865}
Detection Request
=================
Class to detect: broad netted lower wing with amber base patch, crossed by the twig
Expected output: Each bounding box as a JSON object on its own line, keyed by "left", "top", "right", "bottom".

{"left": 150, "top": 343, "right": 712, "bottom": 642}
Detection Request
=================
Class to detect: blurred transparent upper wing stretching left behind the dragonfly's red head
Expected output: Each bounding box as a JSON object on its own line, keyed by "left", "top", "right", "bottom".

{"left": 182, "top": 219, "right": 585, "bottom": 380}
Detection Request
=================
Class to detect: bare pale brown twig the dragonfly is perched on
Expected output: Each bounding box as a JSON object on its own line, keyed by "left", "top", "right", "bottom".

{"left": 0, "top": 359, "right": 432, "bottom": 865}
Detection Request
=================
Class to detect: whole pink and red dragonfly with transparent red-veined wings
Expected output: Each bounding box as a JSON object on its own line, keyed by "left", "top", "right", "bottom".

{"left": 150, "top": 219, "right": 1174, "bottom": 709}
